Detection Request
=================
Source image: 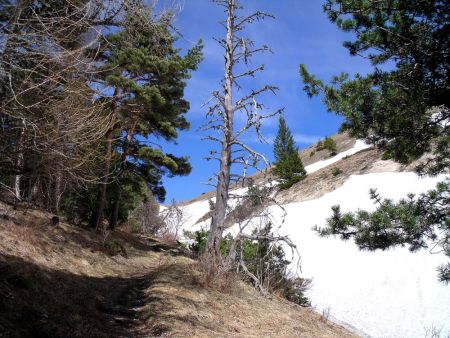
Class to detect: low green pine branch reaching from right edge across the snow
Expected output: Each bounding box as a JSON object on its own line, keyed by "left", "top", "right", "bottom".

{"left": 316, "top": 179, "right": 450, "bottom": 283}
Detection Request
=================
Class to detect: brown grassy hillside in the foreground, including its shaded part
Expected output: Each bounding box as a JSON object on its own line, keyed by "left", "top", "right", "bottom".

{"left": 0, "top": 203, "right": 355, "bottom": 338}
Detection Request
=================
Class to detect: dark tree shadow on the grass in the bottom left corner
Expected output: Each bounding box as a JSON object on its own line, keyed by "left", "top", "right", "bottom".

{"left": 0, "top": 255, "right": 153, "bottom": 338}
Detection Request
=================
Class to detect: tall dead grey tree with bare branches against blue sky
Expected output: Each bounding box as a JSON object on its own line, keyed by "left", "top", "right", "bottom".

{"left": 203, "top": 0, "right": 282, "bottom": 265}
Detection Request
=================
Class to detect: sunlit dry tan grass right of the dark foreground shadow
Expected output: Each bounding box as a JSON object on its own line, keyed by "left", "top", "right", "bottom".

{"left": 144, "top": 258, "right": 356, "bottom": 338}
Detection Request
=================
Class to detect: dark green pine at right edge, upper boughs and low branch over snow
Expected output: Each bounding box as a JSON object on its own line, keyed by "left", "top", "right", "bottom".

{"left": 300, "top": 0, "right": 450, "bottom": 282}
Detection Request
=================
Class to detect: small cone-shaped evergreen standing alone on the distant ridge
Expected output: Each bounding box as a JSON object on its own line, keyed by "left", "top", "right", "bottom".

{"left": 272, "top": 117, "right": 306, "bottom": 189}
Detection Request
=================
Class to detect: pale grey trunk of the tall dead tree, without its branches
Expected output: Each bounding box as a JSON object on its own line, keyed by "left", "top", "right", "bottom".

{"left": 207, "top": 0, "right": 236, "bottom": 261}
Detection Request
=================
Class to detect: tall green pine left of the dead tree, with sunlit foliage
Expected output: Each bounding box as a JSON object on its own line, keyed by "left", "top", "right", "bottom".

{"left": 91, "top": 1, "right": 201, "bottom": 229}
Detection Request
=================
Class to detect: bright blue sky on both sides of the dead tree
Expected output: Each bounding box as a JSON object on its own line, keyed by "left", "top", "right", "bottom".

{"left": 158, "top": 0, "right": 370, "bottom": 202}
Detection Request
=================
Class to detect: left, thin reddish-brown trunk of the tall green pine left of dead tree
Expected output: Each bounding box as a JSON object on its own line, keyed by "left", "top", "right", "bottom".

{"left": 91, "top": 88, "right": 119, "bottom": 229}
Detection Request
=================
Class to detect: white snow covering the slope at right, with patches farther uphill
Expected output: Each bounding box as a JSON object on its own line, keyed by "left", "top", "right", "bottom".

{"left": 178, "top": 141, "right": 450, "bottom": 338}
